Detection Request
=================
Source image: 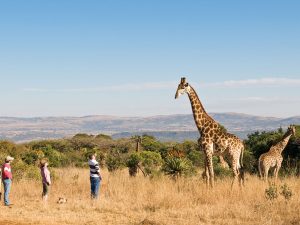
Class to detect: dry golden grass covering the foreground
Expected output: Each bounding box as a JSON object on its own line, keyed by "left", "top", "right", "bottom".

{"left": 0, "top": 168, "right": 300, "bottom": 225}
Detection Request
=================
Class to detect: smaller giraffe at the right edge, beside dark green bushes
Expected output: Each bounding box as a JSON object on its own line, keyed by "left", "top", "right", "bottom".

{"left": 258, "top": 125, "right": 296, "bottom": 181}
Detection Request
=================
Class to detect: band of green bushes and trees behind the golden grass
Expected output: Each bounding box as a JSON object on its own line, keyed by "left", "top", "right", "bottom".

{"left": 0, "top": 126, "right": 300, "bottom": 179}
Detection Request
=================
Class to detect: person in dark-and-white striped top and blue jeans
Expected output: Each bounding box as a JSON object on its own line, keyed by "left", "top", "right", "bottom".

{"left": 89, "top": 154, "right": 101, "bottom": 199}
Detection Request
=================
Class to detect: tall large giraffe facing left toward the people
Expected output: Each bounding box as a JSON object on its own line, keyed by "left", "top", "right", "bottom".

{"left": 175, "top": 78, "right": 244, "bottom": 187}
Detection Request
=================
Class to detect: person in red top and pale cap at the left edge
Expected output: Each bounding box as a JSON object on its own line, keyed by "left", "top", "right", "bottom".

{"left": 2, "top": 156, "right": 14, "bottom": 206}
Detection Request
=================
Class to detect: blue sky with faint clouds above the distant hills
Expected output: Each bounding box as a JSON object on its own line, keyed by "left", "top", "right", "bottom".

{"left": 0, "top": 0, "right": 300, "bottom": 117}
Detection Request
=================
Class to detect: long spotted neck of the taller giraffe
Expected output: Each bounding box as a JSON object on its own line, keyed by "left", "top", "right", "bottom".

{"left": 188, "top": 86, "right": 213, "bottom": 131}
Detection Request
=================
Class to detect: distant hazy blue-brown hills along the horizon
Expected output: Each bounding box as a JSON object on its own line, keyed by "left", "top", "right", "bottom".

{"left": 0, "top": 113, "right": 300, "bottom": 142}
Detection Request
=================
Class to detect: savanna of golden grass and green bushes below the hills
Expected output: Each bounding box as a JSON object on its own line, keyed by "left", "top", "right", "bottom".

{"left": 0, "top": 127, "right": 300, "bottom": 225}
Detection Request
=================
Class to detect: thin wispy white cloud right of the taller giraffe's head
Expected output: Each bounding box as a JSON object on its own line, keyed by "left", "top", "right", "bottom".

{"left": 200, "top": 77, "right": 300, "bottom": 87}
